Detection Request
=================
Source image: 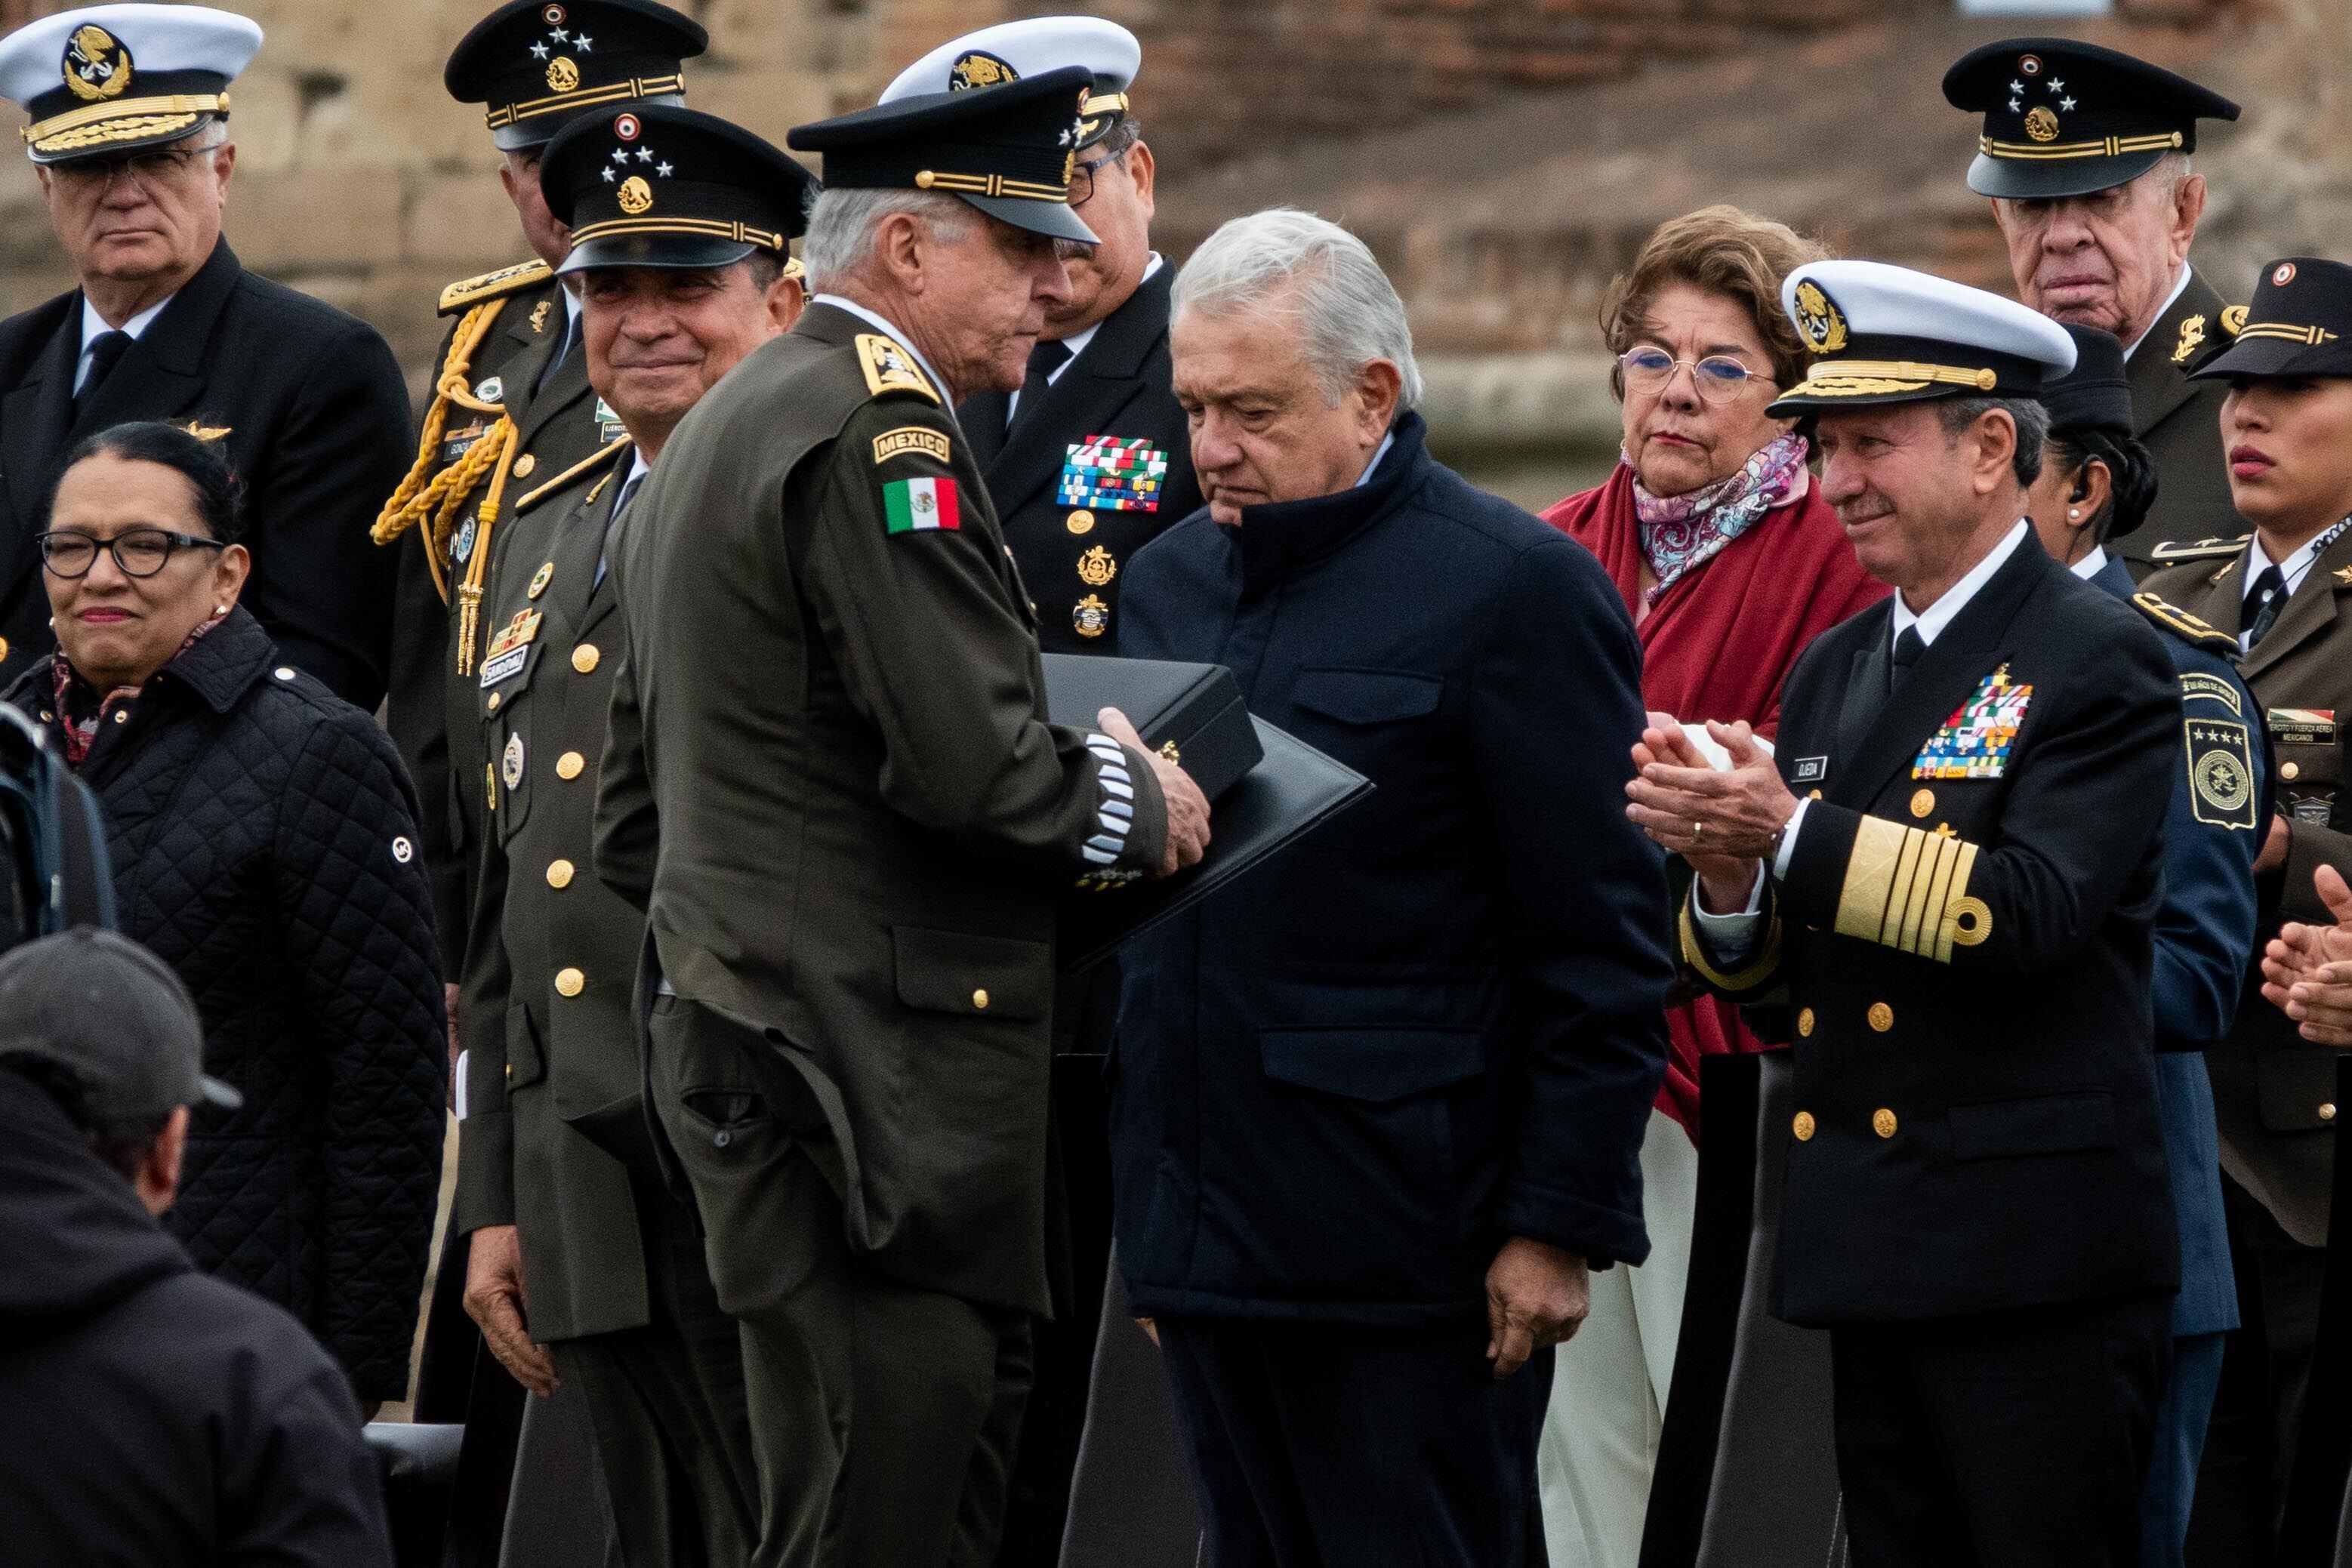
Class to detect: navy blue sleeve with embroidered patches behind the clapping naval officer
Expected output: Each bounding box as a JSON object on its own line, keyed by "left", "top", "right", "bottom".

{"left": 2150, "top": 648, "right": 2270, "bottom": 1051}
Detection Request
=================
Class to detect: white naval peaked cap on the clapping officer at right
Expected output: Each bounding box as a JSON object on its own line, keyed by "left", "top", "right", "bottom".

{"left": 1766, "top": 261, "right": 2074, "bottom": 418}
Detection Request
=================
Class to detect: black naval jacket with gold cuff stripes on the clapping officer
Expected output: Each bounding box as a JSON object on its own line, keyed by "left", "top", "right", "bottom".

{"left": 1682, "top": 531, "right": 2181, "bottom": 1326}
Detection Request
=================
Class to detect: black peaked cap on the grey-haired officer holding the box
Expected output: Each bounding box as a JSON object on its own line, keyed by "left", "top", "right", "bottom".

{"left": 785, "top": 66, "right": 1096, "bottom": 245}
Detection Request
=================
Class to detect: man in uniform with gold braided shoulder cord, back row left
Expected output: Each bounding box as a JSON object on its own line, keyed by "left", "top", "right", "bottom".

{"left": 374, "top": 0, "right": 711, "bottom": 982}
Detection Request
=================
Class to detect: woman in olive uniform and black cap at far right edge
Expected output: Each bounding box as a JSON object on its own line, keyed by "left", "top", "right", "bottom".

{"left": 2147, "top": 256, "right": 2352, "bottom": 1568}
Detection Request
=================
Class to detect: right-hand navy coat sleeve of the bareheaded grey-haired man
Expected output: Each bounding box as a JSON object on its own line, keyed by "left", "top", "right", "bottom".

{"left": 1470, "top": 538, "right": 1672, "bottom": 1262}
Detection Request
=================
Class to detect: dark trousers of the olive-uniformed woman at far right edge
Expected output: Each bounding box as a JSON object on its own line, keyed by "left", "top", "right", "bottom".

{"left": 2187, "top": 1173, "right": 2329, "bottom": 1568}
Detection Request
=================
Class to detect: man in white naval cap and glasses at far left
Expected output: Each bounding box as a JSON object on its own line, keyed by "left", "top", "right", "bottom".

{"left": 0, "top": 5, "right": 409, "bottom": 707}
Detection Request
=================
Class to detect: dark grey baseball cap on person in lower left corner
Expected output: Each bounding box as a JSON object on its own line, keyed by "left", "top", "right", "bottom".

{"left": 0, "top": 926, "right": 245, "bottom": 1123}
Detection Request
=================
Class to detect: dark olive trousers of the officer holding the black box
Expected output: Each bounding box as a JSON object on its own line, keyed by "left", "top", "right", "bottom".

{"left": 649, "top": 997, "right": 1032, "bottom": 1568}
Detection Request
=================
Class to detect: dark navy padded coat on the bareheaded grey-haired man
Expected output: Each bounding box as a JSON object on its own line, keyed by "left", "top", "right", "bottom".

{"left": 1110, "top": 414, "right": 1672, "bottom": 1323}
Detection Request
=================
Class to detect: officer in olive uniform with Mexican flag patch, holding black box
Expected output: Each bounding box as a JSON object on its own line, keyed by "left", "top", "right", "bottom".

{"left": 592, "top": 68, "right": 1209, "bottom": 1566}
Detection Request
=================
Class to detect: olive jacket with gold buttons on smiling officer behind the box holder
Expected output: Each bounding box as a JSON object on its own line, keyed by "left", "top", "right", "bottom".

{"left": 452, "top": 442, "right": 649, "bottom": 1342}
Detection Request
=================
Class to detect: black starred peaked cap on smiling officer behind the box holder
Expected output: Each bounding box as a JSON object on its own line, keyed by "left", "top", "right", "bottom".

{"left": 538, "top": 103, "right": 816, "bottom": 273}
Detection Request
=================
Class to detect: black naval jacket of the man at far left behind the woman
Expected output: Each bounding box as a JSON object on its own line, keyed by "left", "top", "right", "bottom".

{"left": 0, "top": 240, "right": 412, "bottom": 707}
